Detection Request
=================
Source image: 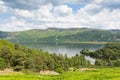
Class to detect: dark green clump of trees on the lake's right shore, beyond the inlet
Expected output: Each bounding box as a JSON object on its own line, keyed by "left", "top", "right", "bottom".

{"left": 81, "top": 43, "right": 120, "bottom": 66}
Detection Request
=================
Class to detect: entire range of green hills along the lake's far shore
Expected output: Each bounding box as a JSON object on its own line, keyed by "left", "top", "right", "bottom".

{"left": 0, "top": 28, "right": 120, "bottom": 42}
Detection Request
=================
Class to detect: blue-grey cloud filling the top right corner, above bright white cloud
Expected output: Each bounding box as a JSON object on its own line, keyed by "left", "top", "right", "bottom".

{"left": 82, "top": 0, "right": 120, "bottom": 15}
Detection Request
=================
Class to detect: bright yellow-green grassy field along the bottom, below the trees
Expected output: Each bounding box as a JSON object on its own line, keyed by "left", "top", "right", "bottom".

{"left": 0, "top": 68, "right": 120, "bottom": 80}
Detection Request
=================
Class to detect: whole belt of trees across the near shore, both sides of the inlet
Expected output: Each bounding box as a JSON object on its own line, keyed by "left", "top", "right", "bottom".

{"left": 0, "top": 40, "right": 120, "bottom": 73}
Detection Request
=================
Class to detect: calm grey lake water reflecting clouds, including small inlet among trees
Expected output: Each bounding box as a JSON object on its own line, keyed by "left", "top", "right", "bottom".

{"left": 21, "top": 43, "right": 103, "bottom": 64}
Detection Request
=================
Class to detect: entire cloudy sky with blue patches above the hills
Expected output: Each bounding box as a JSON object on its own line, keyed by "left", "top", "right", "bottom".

{"left": 0, "top": 0, "right": 120, "bottom": 31}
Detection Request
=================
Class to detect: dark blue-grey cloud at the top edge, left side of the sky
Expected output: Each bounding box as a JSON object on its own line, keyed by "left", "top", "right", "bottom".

{"left": 4, "top": 0, "right": 45, "bottom": 9}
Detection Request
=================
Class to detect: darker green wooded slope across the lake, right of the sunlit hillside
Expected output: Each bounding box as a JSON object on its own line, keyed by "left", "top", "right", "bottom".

{"left": 38, "top": 30, "right": 120, "bottom": 42}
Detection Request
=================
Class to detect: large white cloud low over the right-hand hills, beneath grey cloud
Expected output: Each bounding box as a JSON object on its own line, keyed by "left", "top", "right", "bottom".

{"left": 77, "top": 9, "right": 120, "bottom": 29}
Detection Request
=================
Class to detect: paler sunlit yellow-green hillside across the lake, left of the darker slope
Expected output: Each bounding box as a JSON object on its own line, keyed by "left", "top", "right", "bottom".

{"left": 10, "top": 28, "right": 92, "bottom": 42}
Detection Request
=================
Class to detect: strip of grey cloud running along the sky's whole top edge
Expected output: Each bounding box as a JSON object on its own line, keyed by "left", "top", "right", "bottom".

{"left": 2, "top": 0, "right": 120, "bottom": 10}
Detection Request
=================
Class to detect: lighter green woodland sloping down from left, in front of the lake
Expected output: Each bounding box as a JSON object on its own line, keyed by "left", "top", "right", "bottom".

{"left": 0, "top": 40, "right": 90, "bottom": 73}
